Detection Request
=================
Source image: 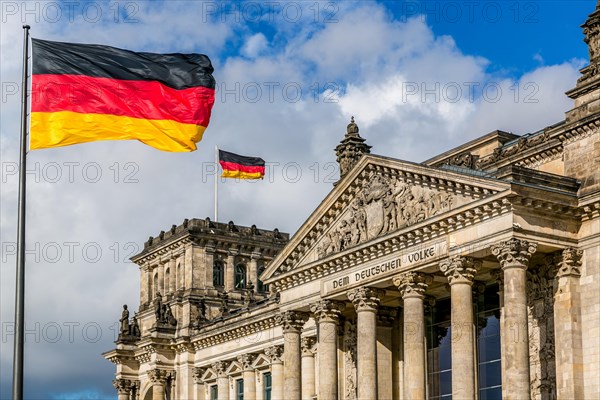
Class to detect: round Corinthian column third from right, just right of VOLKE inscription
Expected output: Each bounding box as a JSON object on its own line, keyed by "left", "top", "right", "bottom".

{"left": 440, "top": 256, "right": 481, "bottom": 400}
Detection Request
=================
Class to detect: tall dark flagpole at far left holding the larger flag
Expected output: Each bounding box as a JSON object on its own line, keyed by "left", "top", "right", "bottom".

{"left": 12, "top": 25, "right": 30, "bottom": 400}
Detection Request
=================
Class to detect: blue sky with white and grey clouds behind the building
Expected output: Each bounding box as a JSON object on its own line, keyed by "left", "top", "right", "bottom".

{"left": 0, "top": 0, "right": 596, "bottom": 399}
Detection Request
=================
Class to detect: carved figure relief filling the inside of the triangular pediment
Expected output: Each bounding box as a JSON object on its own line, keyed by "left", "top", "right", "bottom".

{"left": 317, "top": 175, "right": 458, "bottom": 258}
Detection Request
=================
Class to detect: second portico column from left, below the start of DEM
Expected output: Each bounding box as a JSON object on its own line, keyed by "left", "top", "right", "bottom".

{"left": 310, "top": 300, "right": 346, "bottom": 400}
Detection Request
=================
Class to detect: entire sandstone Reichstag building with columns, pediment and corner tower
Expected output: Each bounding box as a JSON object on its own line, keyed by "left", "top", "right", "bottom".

{"left": 104, "top": 7, "right": 600, "bottom": 400}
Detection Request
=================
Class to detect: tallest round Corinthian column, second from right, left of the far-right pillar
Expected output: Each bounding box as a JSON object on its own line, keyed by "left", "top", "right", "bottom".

{"left": 491, "top": 238, "right": 537, "bottom": 400}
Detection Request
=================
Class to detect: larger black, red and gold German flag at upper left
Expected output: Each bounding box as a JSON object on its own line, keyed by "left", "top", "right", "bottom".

{"left": 30, "top": 39, "right": 215, "bottom": 151}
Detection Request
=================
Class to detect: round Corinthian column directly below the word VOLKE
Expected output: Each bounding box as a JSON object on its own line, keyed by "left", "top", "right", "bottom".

{"left": 393, "top": 272, "right": 433, "bottom": 399}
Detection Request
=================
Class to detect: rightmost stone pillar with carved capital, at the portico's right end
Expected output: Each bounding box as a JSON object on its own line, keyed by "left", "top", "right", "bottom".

{"left": 554, "top": 249, "right": 584, "bottom": 400}
